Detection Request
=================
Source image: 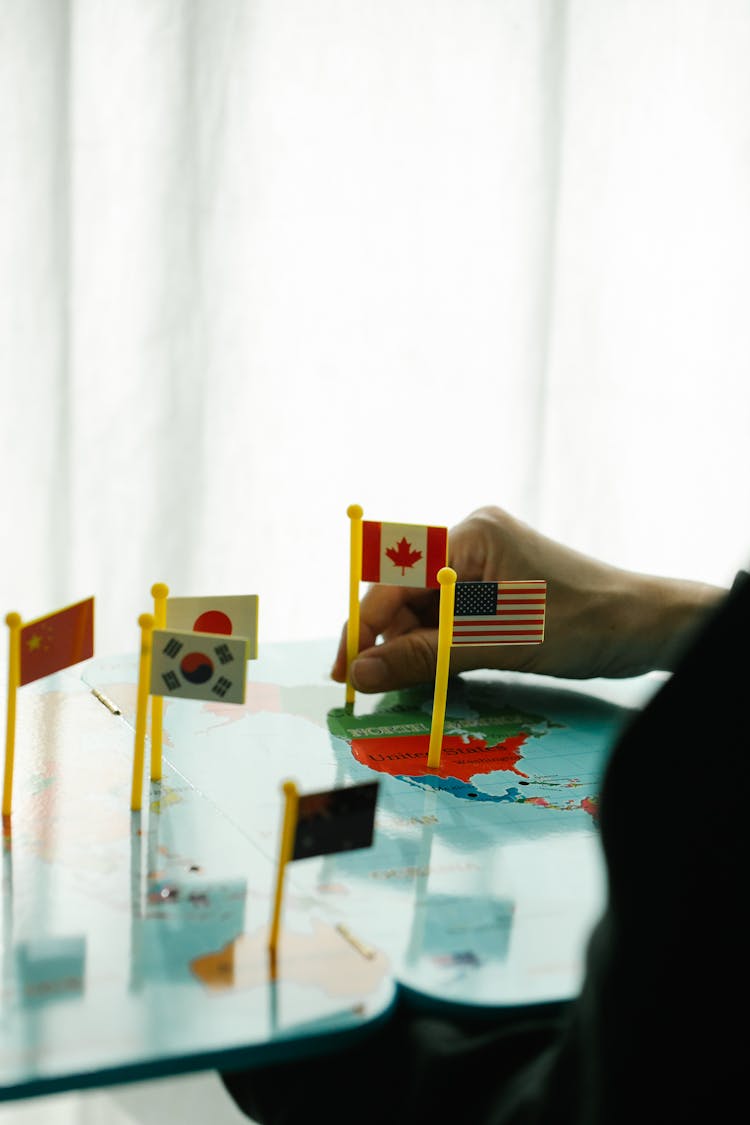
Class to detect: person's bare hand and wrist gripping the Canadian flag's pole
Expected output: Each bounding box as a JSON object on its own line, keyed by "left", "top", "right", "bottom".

{"left": 331, "top": 506, "right": 724, "bottom": 693}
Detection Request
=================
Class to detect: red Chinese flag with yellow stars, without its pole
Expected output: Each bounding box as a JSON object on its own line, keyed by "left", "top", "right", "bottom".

{"left": 18, "top": 597, "right": 93, "bottom": 685}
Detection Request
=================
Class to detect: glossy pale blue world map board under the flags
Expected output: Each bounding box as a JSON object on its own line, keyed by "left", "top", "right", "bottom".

{"left": 0, "top": 641, "right": 653, "bottom": 1092}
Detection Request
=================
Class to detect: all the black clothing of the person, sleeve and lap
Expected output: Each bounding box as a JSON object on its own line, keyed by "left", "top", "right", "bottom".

{"left": 223, "top": 573, "right": 750, "bottom": 1125}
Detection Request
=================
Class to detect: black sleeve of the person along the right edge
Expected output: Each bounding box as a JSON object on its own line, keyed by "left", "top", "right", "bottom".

{"left": 531, "top": 572, "right": 750, "bottom": 1125}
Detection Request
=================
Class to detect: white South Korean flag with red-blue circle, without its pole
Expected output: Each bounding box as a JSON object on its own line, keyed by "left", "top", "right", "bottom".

{"left": 150, "top": 629, "right": 247, "bottom": 703}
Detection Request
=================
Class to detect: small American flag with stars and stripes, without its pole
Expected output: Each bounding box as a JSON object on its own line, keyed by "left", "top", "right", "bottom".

{"left": 451, "top": 579, "right": 546, "bottom": 645}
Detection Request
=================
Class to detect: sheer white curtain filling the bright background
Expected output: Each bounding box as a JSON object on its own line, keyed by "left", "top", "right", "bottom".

{"left": 0, "top": 0, "right": 750, "bottom": 1118}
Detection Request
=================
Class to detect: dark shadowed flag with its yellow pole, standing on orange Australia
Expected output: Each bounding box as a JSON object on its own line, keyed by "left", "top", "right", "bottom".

{"left": 269, "top": 781, "right": 380, "bottom": 978}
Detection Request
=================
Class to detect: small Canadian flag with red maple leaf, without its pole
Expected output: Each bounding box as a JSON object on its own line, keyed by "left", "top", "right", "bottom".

{"left": 362, "top": 520, "right": 448, "bottom": 590}
